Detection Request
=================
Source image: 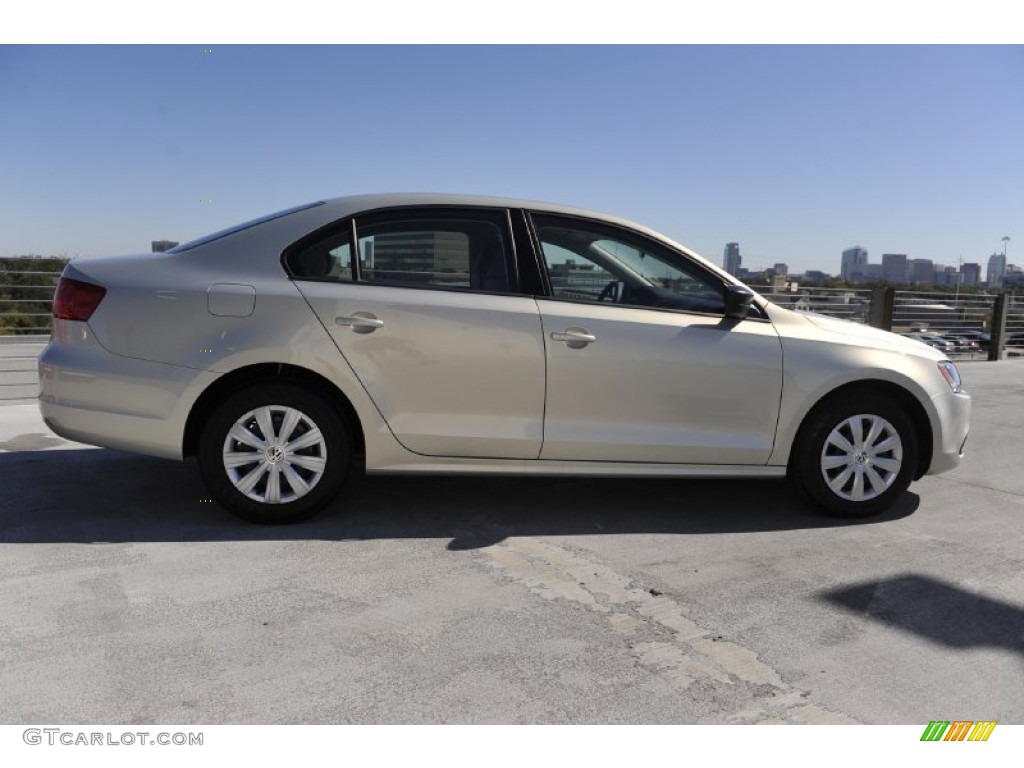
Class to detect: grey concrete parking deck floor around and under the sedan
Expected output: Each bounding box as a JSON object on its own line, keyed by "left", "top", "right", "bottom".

{"left": 0, "top": 361, "right": 1024, "bottom": 725}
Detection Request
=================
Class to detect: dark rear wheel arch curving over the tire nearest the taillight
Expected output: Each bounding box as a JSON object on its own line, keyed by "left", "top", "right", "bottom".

{"left": 181, "top": 362, "right": 366, "bottom": 457}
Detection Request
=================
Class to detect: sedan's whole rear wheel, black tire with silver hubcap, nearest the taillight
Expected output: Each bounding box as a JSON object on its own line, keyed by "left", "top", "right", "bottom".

{"left": 199, "top": 383, "right": 352, "bottom": 524}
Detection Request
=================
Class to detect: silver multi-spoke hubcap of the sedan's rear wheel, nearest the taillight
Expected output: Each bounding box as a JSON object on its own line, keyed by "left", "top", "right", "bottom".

{"left": 222, "top": 406, "right": 327, "bottom": 504}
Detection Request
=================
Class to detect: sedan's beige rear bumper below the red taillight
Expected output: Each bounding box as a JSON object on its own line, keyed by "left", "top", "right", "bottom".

{"left": 39, "top": 321, "right": 216, "bottom": 459}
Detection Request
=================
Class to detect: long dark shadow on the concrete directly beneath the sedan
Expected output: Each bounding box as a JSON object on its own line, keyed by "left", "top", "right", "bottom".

{"left": 0, "top": 449, "right": 919, "bottom": 550}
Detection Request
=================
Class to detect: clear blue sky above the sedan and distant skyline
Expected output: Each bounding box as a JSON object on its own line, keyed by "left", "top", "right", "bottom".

{"left": 0, "top": 45, "right": 1024, "bottom": 272}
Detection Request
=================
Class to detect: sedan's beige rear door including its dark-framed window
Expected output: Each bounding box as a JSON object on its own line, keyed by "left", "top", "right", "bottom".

{"left": 286, "top": 208, "right": 545, "bottom": 459}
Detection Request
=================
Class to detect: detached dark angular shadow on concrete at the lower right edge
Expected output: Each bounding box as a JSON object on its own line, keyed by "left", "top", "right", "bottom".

{"left": 819, "top": 573, "right": 1024, "bottom": 653}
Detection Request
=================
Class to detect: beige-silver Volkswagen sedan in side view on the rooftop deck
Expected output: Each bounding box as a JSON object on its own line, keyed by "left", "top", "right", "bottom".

{"left": 39, "top": 195, "right": 970, "bottom": 523}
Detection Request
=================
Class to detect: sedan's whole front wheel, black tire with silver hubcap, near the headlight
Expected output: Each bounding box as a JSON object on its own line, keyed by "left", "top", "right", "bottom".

{"left": 790, "top": 392, "right": 918, "bottom": 517}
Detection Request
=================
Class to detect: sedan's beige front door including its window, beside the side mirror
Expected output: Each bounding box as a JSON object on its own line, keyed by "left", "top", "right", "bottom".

{"left": 531, "top": 214, "right": 782, "bottom": 465}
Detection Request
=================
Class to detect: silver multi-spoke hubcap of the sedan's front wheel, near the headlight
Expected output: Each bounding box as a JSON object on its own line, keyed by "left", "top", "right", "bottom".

{"left": 821, "top": 414, "right": 903, "bottom": 502}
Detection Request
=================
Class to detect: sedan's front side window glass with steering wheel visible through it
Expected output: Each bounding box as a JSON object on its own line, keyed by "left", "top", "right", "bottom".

{"left": 531, "top": 214, "right": 725, "bottom": 313}
